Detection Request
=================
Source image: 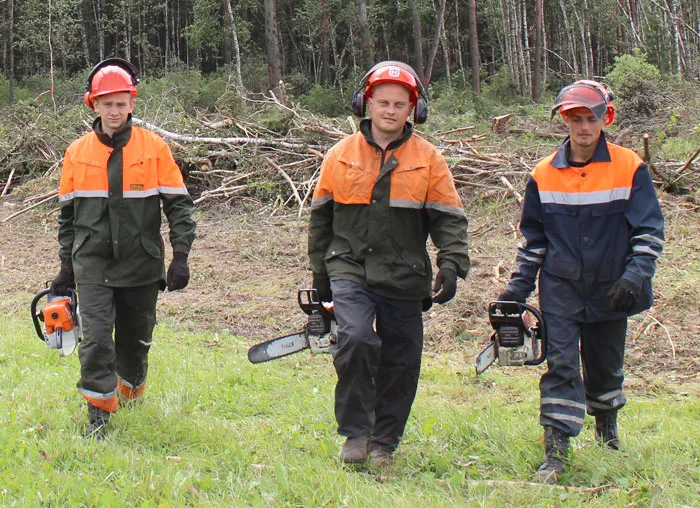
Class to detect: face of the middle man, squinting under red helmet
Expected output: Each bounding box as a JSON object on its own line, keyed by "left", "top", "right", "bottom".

{"left": 368, "top": 83, "right": 413, "bottom": 137}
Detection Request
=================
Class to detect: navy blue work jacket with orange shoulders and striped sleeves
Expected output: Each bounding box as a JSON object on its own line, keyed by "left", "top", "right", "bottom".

{"left": 506, "top": 133, "right": 664, "bottom": 322}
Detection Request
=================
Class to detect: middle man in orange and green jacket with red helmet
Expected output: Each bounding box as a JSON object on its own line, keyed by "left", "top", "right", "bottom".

{"left": 308, "top": 61, "right": 469, "bottom": 464}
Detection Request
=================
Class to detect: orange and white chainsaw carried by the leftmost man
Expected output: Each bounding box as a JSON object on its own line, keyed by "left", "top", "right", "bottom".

{"left": 31, "top": 288, "right": 83, "bottom": 356}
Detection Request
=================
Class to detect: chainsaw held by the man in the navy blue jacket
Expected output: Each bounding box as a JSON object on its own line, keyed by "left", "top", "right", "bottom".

{"left": 476, "top": 301, "right": 547, "bottom": 375}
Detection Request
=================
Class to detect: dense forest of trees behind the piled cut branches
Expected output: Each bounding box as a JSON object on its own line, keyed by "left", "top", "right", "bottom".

{"left": 0, "top": 0, "right": 700, "bottom": 103}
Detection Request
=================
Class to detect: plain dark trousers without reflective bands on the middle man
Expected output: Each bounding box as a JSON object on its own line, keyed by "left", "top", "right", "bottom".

{"left": 331, "top": 280, "right": 423, "bottom": 451}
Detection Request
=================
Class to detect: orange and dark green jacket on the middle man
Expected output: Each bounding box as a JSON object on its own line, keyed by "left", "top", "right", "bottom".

{"left": 308, "top": 119, "right": 469, "bottom": 300}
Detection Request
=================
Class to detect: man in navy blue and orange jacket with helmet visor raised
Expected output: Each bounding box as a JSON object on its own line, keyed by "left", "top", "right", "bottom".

{"left": 499, "top": 80, "right": 664, "bottom": 483}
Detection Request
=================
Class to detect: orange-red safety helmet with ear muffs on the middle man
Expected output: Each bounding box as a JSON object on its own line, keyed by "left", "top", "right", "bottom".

{"left": 352, "top": 60, "right": 428, "bottom": 124}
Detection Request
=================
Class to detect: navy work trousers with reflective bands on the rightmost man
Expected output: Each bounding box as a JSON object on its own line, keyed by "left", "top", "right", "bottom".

{"left": 540, "top": 313, "right": 627, "bottom": 436}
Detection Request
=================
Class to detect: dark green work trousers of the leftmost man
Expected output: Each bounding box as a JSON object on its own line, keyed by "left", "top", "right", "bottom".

{"left": 78, "top": 282, "right": 159, "bottom": 400}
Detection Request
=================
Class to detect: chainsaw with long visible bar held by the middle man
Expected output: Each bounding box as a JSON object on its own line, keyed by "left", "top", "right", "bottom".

{"left": 248, "top": 289, "right": 338, "bottom": 363}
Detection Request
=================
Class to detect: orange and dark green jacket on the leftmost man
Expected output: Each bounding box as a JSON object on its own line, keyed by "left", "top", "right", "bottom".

{"left": 58, "top": 116, "right": 195, "bottom": 288}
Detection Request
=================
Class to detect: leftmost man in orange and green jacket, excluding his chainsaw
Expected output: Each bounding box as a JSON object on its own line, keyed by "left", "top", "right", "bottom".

{"left": 51, "top": 58, "right": 195, "bottom": 438}
